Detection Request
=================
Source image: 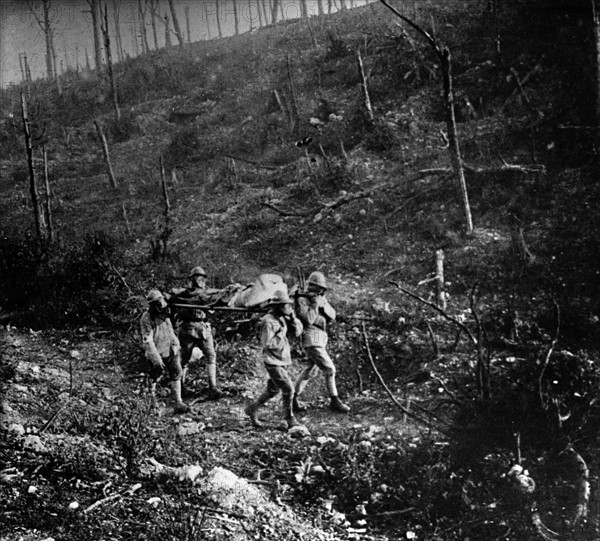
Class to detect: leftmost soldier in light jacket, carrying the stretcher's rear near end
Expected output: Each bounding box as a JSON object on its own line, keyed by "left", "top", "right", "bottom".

{"left": 140, "top": 289, "right": 190, "bottom": 413}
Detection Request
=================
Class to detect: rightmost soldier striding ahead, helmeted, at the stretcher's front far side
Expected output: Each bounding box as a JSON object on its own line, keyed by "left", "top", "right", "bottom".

{"left": 294, "top": 271, "right": 350, "bottom": 413}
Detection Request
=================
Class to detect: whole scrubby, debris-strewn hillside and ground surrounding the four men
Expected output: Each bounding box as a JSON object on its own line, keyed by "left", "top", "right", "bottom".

{"left": 0, "top": 1, "right": 600, "bottom": 541}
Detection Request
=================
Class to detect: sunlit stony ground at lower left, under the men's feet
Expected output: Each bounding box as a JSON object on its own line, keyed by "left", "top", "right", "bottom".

{"left": 0, "top": 327, "right": 426, "bottom": 541}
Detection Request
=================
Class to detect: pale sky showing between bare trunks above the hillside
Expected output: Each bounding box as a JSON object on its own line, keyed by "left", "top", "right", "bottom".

{"left": 0, "top": 0, "right": 366, "bottom": 87}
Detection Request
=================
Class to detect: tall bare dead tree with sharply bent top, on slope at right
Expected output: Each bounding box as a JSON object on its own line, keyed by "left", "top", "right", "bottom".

{"left": 379, "top": 0, "right": 473, "bottom": 235}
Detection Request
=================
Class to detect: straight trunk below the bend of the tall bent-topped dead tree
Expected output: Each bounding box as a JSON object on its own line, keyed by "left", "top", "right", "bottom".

{"left": 440, "top": 47, "right": 473, "bottom": 235}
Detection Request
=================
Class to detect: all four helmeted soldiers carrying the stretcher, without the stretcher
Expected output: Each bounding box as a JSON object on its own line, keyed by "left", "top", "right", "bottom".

{"left": 140, "top": 267, "right": 350, "bottom": 428}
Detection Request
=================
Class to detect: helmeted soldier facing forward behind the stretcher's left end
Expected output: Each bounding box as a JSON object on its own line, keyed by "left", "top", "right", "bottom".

{"left": 169, "top": 267, "right": 223, "bottom": 400}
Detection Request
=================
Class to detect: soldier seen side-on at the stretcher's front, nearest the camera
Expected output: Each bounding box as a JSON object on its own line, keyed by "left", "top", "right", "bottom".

{"left": 244, "top": 290, "right": 302, "bottom": 428}
